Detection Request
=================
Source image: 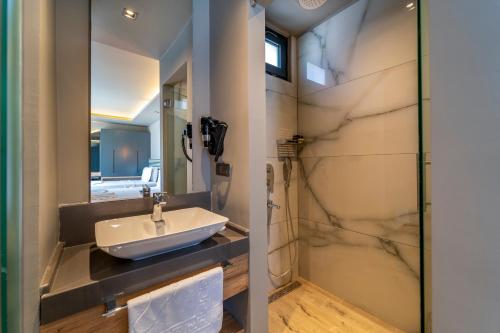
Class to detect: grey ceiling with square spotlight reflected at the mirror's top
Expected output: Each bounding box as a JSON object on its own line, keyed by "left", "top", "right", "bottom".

{"left": 92, "top": 0, "right": 192, "bottom": 59}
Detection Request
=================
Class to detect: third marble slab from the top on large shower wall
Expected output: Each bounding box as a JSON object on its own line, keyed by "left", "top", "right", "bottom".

{"left": 299, "top": 154, "right": 419, "bottom": 246}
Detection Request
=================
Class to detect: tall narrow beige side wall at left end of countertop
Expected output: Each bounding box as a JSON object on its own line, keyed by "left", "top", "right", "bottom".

{"left": 19, "top": 0, "right": 59, "bottom": 332}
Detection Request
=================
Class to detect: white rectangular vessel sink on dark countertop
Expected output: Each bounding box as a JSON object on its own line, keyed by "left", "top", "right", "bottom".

{"left": 95, "top": 207, "right": 229, "bottom": 260}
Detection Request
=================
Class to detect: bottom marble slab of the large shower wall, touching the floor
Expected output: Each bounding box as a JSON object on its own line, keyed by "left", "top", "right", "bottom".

{"left": 299, "top": 220, "right": 420, "bottom": 333}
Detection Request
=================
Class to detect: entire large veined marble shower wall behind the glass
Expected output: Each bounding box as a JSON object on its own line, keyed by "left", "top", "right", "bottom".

{"left": 298, "top": 0, "right": 420, "bottom": 333}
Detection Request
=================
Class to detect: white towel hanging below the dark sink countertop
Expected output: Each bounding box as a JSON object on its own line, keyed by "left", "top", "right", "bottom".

{"left": 127, "top": 267, "right": 223, "bottom": 333}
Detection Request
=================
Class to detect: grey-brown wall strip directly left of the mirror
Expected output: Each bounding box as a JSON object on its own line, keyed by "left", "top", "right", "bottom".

{"left": 56, "top": 0, "right": 90, "bottom": 203}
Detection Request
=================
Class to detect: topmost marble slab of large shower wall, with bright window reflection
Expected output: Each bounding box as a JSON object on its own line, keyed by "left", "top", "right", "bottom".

{"left": 298, "top": 0, "right": 417, "bottom": 96}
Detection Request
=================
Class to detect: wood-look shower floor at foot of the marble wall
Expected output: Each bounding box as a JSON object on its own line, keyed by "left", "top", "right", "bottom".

{"left": 269, "top": 279, "right": 403, "bottom": 333}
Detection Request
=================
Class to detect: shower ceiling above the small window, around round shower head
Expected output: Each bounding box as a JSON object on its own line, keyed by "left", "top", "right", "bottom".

{"left": 266, "top": 0, "right": 353, "bottom": 36}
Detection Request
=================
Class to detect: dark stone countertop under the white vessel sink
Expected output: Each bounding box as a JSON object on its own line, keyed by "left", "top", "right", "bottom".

{"left": 40, "top": 225, "right": 249, "bottom": 325}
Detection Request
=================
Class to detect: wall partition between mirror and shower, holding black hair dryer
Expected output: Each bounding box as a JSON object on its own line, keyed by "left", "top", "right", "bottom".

{"left": 210, "top": 0, "right": 267, "bottom": 333}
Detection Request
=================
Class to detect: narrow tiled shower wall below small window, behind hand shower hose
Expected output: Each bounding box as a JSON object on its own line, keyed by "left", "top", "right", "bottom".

{"left": 266, "top": 37, "right": 299, "bottom": 291}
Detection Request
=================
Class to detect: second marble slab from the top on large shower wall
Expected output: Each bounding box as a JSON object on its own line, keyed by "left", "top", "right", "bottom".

{"left": 298, "top": 61, "right": 418, "bottom": 157}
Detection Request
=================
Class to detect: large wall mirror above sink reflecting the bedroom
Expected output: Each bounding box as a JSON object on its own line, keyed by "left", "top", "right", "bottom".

{"left": 90, "top": 0, "right": 193, "bottom": 202}
